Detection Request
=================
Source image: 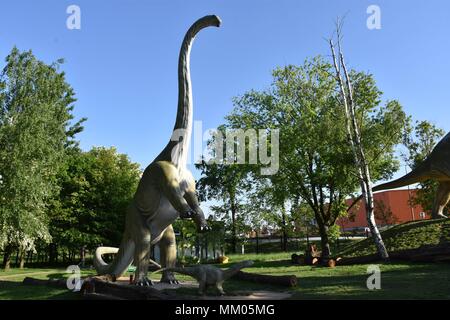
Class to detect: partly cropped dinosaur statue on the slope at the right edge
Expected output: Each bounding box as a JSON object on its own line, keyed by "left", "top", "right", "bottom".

{"left": 348, "top": 133, "right": 450, "bottom": 219}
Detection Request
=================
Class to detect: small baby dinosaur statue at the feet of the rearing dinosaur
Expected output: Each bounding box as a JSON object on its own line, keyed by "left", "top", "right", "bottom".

{"left": 155, "top": 260, "right": 253, "bottom": 295}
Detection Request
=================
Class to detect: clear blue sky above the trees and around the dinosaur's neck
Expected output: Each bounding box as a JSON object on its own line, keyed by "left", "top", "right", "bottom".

{"left": 0, "top": 0, "right": 450, "bottom": 182}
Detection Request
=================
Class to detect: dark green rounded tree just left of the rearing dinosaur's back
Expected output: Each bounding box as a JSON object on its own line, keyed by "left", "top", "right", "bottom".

{"left": 46, "top": 147, "right": 141, "bottom": 257}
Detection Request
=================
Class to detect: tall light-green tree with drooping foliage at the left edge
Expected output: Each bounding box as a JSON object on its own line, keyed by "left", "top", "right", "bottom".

{"left": 0, "top": 48, "right": 82, "bottom": 268}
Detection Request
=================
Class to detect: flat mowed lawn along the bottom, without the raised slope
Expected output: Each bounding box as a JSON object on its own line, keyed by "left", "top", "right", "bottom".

{"left": 0, "top": 260, "right": 450, "bottom": 300}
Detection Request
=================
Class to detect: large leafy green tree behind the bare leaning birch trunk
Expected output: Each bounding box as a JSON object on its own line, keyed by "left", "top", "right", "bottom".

{"left": 227, "top": 57, "right": 406, "bottom": 258}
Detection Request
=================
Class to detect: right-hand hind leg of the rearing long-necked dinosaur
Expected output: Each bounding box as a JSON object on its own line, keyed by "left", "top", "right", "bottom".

{"left": 159, "top": 225, "right": 179, "bottom": 284}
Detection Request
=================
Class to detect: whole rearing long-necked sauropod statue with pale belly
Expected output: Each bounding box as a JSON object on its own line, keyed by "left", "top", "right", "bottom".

{"left": 94, "top": 15, "right": 221, "bottom": 286}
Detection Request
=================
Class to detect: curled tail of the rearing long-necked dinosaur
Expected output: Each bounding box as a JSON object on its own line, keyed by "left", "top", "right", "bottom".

{"left": 94, "top": 237, "right": 134, "bottom": 278}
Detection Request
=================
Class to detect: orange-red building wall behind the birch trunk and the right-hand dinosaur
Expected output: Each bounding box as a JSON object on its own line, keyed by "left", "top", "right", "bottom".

{"left": 337, "top": 189, "right": 430, "bottom": 230}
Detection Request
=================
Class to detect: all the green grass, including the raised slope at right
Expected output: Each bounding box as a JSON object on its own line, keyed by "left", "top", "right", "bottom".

{"left": 0, "top": 220, "right": 450, "bottom": 300}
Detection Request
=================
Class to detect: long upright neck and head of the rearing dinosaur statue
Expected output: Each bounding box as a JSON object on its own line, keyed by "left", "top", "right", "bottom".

{"left": 156, "top": 16, "right": 220, "bottom": 168}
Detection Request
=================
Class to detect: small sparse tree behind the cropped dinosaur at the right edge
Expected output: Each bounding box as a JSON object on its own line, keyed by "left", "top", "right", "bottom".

{"left": 403, "top": 121, "right": 450, "bottom": 213}
